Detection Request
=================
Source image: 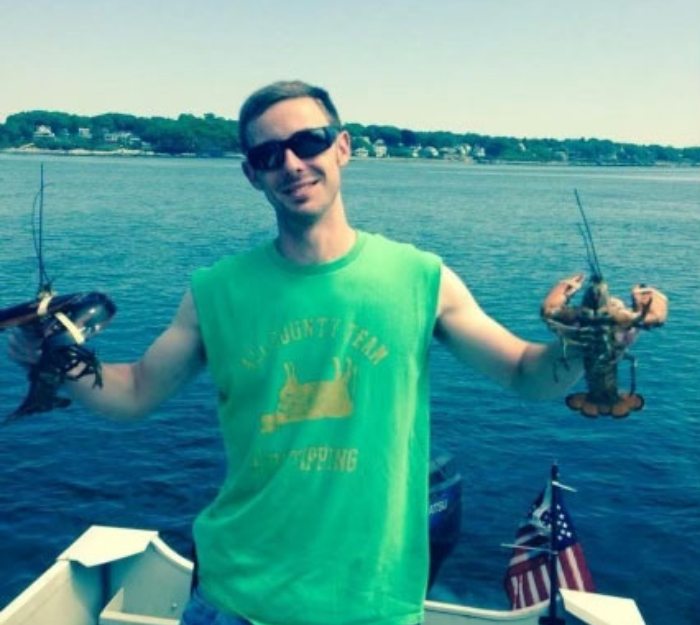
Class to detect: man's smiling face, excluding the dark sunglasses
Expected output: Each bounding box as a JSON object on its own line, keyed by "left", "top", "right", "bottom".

{"left": 243, "top": 98, "right": 350, "bottom": 224}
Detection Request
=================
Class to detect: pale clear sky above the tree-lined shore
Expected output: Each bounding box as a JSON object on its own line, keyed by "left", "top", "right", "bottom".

{"left": 0, "top": 0, "right": 700, "bottom": 147}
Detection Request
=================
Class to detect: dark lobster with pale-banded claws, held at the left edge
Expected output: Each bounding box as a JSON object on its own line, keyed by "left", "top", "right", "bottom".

{"left": 0, "top": 166, "right": 117, "bottom": 421}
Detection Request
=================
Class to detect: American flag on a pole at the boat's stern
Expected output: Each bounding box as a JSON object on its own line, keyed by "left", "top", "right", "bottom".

{"left": 504, "top": 483, "right": 593, "bottom": 610}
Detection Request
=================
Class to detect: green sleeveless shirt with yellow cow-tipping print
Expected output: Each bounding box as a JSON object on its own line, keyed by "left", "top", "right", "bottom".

{"left": 192, "top": 232, "right": 441, "bottom": 625}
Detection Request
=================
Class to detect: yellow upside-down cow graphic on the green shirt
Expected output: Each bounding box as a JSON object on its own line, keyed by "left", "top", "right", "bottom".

{"left": 260, "top": 358, "right": 356, "bottom": 434}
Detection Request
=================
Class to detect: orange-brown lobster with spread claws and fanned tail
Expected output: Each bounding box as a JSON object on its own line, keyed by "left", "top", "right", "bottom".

{"left": 541, "top": 192, "right": 668, "bottom": 418}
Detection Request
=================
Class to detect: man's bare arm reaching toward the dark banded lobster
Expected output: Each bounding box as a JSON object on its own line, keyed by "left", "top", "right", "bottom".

{"left": 66, "top": 291, "right": 205, "bottom": 419}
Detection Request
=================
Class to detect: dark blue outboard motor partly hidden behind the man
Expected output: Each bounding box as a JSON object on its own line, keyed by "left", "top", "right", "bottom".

{"left": 428, "top": 452, "right": 462, "bottom": 590}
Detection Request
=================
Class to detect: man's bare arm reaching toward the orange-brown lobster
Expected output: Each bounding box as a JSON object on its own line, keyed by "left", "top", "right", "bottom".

{"left": 436, "top": 266, "right": 583, "bottom": 399}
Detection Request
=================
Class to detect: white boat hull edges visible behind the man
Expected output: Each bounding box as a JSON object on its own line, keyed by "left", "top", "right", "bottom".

{"left": 0, "top": 525, "right": 644, "bottom": 625}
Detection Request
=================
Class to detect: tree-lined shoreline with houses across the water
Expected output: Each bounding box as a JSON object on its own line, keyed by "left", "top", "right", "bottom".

{"left": 0, "top": 111, "right": 700, "bottom": 166}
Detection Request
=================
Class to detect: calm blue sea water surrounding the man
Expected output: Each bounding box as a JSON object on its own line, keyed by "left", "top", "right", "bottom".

{"left": 0, "top": 155, "right": 700, "bottom": 625}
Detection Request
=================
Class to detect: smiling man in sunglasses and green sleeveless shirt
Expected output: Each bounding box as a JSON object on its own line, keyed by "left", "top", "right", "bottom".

{"left": 11, "top": 82, "right": 581, "bottom": 625}
